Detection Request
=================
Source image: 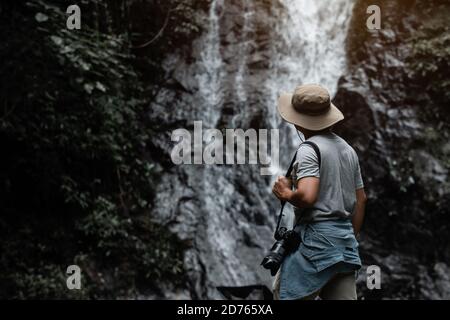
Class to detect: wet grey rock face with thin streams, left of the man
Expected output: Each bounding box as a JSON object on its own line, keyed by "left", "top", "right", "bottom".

{"left": 148, "top": 0, "right": 284, "bottom": 299}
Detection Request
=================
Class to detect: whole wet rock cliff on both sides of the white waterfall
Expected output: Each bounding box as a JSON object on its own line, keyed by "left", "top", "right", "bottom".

{"left": 148, "top": 0, "right": 450, "bottom": 299}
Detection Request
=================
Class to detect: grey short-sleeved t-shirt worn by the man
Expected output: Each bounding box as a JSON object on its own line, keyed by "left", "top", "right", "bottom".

{"left": 292, "top": 132, "right": 364, "bottom": 223}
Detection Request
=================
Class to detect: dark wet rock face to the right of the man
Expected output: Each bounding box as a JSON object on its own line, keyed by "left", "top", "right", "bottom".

{"left": 335, "top": 1, "right": 450, "bottom": 299}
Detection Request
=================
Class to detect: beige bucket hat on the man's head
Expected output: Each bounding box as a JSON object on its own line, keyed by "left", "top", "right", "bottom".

{"left": 278, "top": 84, "right": 344, "bottom": 131}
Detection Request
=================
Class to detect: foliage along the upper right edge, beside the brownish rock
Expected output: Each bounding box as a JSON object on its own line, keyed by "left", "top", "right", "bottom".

{"left": 406, "top": 0, "right": 450, "bottom": 168}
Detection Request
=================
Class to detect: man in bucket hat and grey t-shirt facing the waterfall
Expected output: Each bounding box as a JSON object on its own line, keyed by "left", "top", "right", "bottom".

{"left": 273, "top": 85, "right": 366, "bottom": 300}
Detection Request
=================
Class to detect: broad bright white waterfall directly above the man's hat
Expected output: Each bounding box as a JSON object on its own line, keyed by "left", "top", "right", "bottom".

{"left": 266, "top": 0, "right": 354, "bottom": 140}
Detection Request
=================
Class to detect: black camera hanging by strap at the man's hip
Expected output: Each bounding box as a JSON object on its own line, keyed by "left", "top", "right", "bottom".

{"left": 261, "top": 227, "right": 301, "bottom": 276}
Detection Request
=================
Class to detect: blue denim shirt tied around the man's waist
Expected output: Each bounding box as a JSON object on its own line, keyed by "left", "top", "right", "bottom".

{"left": 280, "top": 219, "right": 361, "bottom": 299}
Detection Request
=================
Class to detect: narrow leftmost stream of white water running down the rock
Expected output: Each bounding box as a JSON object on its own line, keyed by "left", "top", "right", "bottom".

{"left": 198, "top": 0, "right": 249, "bottom": 296}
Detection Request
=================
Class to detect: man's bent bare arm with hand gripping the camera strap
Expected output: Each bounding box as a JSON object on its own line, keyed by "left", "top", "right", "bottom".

{"left": 272, "top": 176, "right": 320, "bottom": 208}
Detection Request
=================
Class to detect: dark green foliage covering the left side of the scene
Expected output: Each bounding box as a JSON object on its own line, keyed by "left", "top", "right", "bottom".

{"left": 0, "top": 0, "right": 183, "bottom": 299}
